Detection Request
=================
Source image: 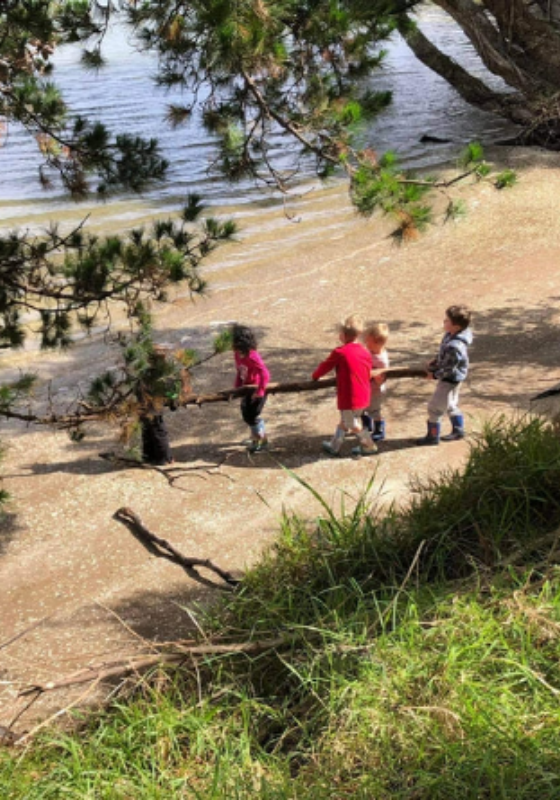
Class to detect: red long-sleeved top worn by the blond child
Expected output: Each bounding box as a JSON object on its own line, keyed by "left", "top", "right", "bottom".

{"left": 311, "top": 342, "right": 372, "bottom": 411}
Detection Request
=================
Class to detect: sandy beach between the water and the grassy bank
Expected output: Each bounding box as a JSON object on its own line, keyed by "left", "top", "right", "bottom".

{"left": 0, "top": 148, "right": 560, "bottom": 728}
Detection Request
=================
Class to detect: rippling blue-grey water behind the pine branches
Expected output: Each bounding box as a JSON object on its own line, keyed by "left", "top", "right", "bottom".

{"left": 0, "top": 6, "right": 513, "bottom": 229}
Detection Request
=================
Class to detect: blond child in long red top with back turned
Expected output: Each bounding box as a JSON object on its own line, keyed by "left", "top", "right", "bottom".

{"left": 311, "top": 314, "right": 377, "bottom": 456}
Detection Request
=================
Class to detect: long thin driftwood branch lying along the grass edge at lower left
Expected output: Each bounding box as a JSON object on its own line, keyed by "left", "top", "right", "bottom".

{"left": 18, "top": 636, "right": 293, "bottom": 697}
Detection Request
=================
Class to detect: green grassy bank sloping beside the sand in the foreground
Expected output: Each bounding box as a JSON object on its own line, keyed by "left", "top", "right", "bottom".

{"left": 0, "top": 419, "right": 560, "bottom": 800}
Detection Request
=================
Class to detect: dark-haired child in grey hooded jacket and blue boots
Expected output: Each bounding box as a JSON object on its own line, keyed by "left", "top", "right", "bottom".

{"left": 417, "top": 306, "right": 473, "bottom": 445}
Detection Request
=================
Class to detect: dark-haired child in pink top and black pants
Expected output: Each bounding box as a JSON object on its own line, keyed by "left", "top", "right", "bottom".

{"left": 231, "top": 325, "right": 270, "bottom": 453}
